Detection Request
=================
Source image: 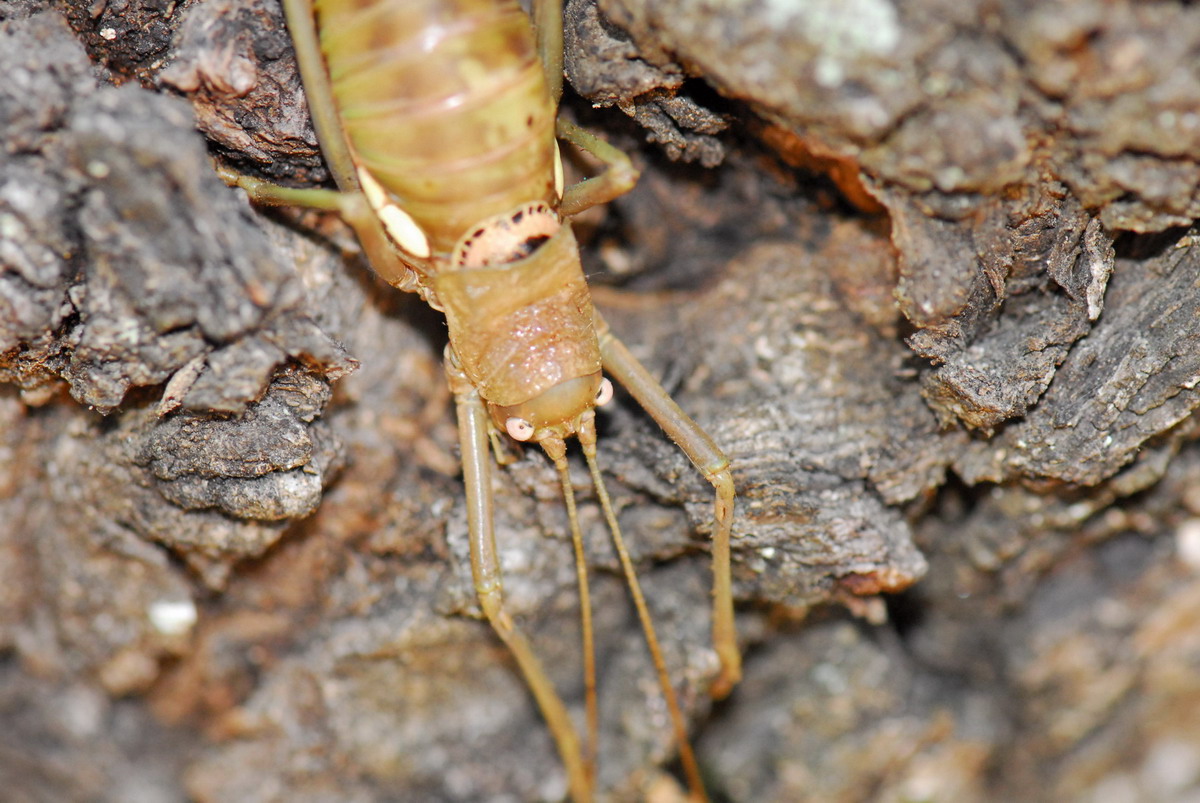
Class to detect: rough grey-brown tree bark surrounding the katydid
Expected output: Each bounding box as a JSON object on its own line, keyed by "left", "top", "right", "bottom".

{"left": 7, "top": 0, "right": 1200, "bottom": 801}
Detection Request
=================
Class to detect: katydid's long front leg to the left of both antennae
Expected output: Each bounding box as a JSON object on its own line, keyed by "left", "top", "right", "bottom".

{"left": 446, "top": 349, "right": 592, "bottom": 803}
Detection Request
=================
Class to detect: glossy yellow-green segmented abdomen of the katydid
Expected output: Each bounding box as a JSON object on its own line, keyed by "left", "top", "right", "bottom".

{"left": 316, "top": 0, "right": 557, "bottom": 253}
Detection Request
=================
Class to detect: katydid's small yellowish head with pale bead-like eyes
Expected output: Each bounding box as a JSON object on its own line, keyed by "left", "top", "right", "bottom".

{"left": 488, "top": 371, "right": 612, "bottom": 442}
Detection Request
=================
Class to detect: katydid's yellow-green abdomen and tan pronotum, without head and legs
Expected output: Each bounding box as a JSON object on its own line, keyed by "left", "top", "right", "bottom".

{"left": 314, "top": 0, "right": 600, "bottom": 406}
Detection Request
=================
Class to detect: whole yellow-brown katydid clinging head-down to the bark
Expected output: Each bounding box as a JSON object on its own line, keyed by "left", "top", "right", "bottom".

{"left": 224, "top": 0, "right": 740, "bottom": 801}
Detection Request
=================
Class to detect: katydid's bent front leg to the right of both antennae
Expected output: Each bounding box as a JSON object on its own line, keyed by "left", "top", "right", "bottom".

{"left": 596, "top": 312, "right": 742, "bottom": 699}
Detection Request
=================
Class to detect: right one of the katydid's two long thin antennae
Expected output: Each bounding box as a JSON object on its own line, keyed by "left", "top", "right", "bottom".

{"left": 578, "top": 415, "right": 708, "bottom": 802}
